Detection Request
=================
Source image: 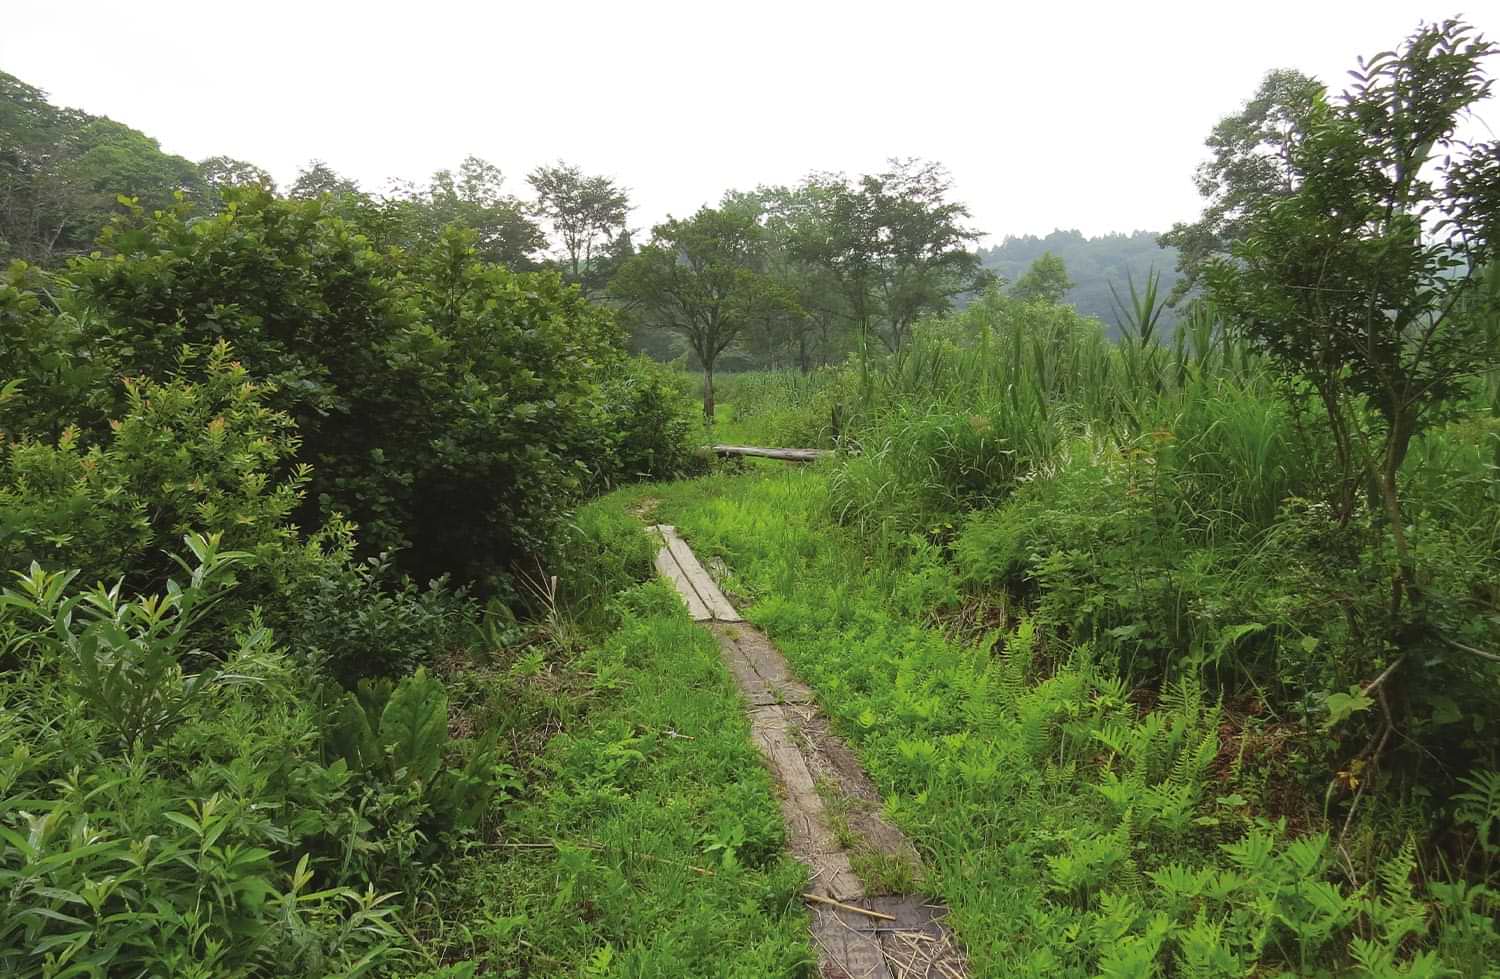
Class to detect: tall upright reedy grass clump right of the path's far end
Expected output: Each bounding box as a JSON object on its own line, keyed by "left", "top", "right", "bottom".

{"left": 830, "top": 286, "right": 1295, "bottom": 538}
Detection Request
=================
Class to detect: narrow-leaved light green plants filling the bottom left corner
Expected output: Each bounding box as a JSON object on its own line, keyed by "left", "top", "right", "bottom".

{"left": 0, "top": 538, "right": 417, "bottom": 978}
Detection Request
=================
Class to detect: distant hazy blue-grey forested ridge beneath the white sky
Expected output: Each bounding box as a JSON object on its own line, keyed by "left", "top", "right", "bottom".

{"left": 980, "top": 228, "right": 1179, "bottom": 333}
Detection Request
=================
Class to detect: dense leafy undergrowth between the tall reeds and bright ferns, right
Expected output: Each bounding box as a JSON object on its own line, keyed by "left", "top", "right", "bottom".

{"left": 953, "top": 419, "right": 1500, "bottom": 766}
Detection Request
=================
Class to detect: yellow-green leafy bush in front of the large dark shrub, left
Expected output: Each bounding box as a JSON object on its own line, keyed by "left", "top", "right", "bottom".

{"left": 0, "top": 343, "right": 334, "bottom": 606}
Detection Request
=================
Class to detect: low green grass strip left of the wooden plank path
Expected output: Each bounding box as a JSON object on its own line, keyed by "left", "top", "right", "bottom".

{"left": 423, "top": 548, "right": 812, "bottom": 979}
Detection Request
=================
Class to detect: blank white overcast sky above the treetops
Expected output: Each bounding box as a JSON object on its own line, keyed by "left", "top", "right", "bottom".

{"left": 0, "top": 0, "right": 1500, "bottom": 240}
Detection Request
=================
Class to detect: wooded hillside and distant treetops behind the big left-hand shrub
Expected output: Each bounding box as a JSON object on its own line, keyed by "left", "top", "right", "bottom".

{"left": 0, "top": 72, "right": 630, "bottom": 287}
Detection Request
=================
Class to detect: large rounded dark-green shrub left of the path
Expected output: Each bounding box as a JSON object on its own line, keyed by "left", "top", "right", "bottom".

{"left": 16, "top": 189, "right": 692, "bottom": 588}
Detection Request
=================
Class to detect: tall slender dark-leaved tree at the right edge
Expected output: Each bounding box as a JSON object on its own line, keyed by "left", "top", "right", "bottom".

{"left": 1208, "top": 21, "right": 1500, "bottom": 606}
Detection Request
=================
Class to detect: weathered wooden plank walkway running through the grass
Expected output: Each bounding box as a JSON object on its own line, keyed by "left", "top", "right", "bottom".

{"left": 651, "top": 525, "right": 968, "bottom": 979}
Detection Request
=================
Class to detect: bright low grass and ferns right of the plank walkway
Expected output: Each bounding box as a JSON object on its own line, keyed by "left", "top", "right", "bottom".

{"left": 606, "top": 468, "right": 1500, "bottom": 978}
